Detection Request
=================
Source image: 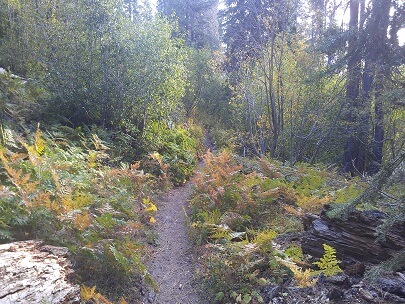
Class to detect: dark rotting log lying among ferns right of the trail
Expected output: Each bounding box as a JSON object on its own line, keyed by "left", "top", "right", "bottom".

{"left": 302, "top": 210, "right": 405, "bottom": 264}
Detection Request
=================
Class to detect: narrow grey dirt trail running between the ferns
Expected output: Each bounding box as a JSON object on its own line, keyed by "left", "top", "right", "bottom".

{"left": 146, "top": 182, "right": 206, "bottom": 304}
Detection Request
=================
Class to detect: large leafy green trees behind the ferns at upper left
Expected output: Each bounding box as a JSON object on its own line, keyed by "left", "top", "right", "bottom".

{"left": 0, "top": 0, "right": 187, "bottom": 135}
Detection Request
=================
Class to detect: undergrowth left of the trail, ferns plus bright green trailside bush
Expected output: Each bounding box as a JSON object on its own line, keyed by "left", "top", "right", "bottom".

{"left": 0, "top": 123, "right": 203, "bottom": 303}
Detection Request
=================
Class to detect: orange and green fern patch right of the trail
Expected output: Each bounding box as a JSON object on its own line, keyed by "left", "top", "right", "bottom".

{"left": 190, "top": 150, "right": 363, "bottom": 303}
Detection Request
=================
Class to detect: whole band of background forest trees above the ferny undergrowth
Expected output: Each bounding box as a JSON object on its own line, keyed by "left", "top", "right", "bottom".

{"left": 0, "top": 0, "right": 404, "bottom": 175}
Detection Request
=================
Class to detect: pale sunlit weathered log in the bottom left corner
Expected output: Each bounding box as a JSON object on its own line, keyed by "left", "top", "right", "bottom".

{"left": 0, "top": 241, "right": 80, "bottom": 304}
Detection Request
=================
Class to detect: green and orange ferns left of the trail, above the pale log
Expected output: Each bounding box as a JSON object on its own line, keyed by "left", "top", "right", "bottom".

{"left": 0, "top": 128, "right": 165, "bottom": 300}
